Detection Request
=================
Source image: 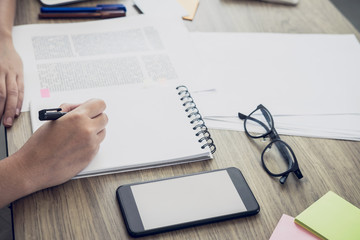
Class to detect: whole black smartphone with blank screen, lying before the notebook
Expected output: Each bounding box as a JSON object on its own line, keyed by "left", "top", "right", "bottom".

{"left": 116, "top": 168, "right": 260, "bottom": 237}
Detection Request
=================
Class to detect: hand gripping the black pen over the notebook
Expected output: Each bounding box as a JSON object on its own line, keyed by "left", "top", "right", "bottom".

{"left": 15, "top": 99, "right": 108, "bottom": 193}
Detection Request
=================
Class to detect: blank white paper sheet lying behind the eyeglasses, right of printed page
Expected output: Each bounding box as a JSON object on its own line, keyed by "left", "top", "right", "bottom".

{"left": 191, "top": 33, "right": 360, "bottom": 116}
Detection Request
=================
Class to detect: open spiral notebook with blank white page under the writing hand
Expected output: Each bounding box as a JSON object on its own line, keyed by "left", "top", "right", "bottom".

{"left": 30, "top": 84, "right": 216, "bottom": 178}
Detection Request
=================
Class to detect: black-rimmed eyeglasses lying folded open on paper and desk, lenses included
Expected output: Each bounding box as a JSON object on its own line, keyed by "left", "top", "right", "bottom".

{"left": 238, "top": 104, "right": 303, "bottom": 184}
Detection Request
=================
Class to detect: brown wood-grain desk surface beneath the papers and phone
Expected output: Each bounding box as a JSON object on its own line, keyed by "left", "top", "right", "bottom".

{"left": 8, "top": 0, "right": 360, "bottom": 239}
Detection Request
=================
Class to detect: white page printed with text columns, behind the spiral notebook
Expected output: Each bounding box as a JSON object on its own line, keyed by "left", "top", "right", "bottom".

{"left": 13, "top": 15, "right": 205, "bottom": 111}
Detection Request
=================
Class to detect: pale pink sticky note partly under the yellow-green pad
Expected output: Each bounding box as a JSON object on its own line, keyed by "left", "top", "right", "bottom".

{"left": 269, "top": 214, "right": 320, "bottom": 240}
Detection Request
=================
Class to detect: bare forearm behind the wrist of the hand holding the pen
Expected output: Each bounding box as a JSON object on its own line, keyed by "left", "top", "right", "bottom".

{"left": 0, "top": 154, "right": 34, "bottom": 208}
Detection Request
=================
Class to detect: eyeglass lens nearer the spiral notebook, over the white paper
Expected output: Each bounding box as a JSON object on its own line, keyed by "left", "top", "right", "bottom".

{"left": 245, "top": 108, "right": 273, "bottom": 137}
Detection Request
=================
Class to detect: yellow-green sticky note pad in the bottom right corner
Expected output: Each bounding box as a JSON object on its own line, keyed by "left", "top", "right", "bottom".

{"left": 295, "top": 191, "right": 360, "bottom": 240}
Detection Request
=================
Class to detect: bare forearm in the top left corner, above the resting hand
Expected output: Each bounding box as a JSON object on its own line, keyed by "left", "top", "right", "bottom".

{"left": 0, "top": 0, "right": 16, "bottom": 39}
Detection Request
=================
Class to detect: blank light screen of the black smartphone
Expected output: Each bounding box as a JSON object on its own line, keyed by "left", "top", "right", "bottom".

{"left": 131, "top": 170, "right": 247, "bottom": 230}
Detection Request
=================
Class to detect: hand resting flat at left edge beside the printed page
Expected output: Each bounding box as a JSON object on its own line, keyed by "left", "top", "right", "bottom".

{"left": 0, "top": 38, "right": 24, "bottom": 127}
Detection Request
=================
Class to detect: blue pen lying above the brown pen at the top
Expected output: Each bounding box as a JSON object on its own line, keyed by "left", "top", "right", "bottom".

{"left": 40, "top": 4, "right": 126, "bottom": 13}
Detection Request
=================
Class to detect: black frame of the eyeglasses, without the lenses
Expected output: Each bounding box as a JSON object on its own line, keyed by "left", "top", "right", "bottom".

{"left": 238, "top": 104, "right": 303, "bottom": 184}
